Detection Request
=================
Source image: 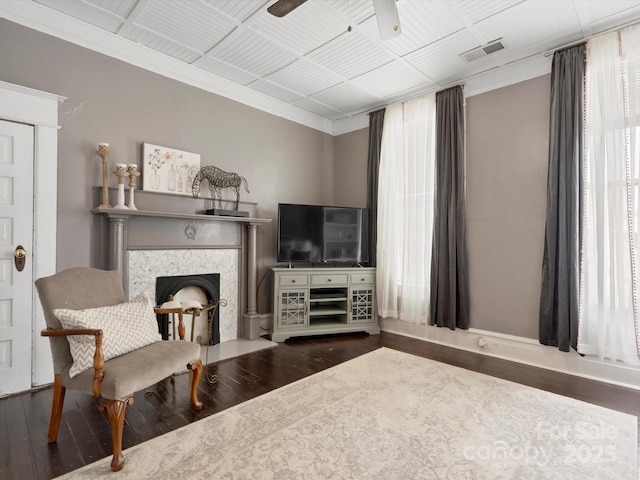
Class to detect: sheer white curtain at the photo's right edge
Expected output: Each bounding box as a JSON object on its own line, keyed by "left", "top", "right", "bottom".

{"left": 578, "top": 27, "right": 640, "bottom": 365}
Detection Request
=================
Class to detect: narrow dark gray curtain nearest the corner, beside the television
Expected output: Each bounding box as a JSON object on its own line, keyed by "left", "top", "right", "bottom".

{"left": 367, "top": 108, "right": 385, "bottom": 267}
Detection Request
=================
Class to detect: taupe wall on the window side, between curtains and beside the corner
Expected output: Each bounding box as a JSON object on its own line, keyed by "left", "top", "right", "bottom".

{"left": 334, "top": 75, "right": 550, "bottom": 339}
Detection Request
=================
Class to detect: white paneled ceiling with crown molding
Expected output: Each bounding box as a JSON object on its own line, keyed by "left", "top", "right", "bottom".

{"left": 0, "top": 0, "right": 640, "bottom": 133}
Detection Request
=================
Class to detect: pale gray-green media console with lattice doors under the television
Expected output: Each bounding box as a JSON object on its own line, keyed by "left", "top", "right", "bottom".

{"left": 269, "top": 267, "right": 380, "bottom": 342}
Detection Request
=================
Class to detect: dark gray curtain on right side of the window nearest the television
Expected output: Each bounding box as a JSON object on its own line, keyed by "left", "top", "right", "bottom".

{"left": 430, "top": 85, "right": 469, "bottom": 330}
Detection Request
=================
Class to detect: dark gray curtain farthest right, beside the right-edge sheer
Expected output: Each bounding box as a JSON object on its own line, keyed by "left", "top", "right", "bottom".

{"left": 539, "top": 43, "right": 586, "bottom": 352}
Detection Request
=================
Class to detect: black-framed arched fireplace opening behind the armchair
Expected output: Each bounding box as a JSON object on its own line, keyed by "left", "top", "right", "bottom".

{"left": 156, "top": 273, "right": 220, "bottom": 345}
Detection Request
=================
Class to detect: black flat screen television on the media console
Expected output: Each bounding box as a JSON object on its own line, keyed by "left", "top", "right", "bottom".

{"left": 277, "top": 203, "right": 369, "bottom": 264}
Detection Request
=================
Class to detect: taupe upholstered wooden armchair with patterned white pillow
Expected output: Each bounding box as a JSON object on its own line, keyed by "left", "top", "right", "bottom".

{"left": 35, "top": 267, "right": 202, "bottom": 472}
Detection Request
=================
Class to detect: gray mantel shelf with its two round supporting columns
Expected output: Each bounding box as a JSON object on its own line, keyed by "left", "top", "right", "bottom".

{"left": 91, "top": 207, "right": 271, "bottom": 340}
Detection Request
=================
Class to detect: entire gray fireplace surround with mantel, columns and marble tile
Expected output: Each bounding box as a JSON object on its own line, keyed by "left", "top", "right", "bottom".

{"left": 92, "top": 191, "right": 271, "bottom": 342}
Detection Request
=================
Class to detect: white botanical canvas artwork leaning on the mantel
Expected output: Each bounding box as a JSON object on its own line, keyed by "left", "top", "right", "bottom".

{"left": 142, "top": 143, "right": 200, "bottom": 195}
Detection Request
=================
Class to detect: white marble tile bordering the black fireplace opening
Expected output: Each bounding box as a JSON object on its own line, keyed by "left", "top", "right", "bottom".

{"left": 127, "top": 248, "right": 239, "bottom": 343}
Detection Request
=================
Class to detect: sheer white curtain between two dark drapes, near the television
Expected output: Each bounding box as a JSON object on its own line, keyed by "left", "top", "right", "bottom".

{"left": 377, "top": 93, "right": 436, "bottom": 324}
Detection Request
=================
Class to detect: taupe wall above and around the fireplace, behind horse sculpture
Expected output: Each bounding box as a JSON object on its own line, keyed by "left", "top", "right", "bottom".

{"left": 0, "top": 19, "right": 333, "bottom": 312}
